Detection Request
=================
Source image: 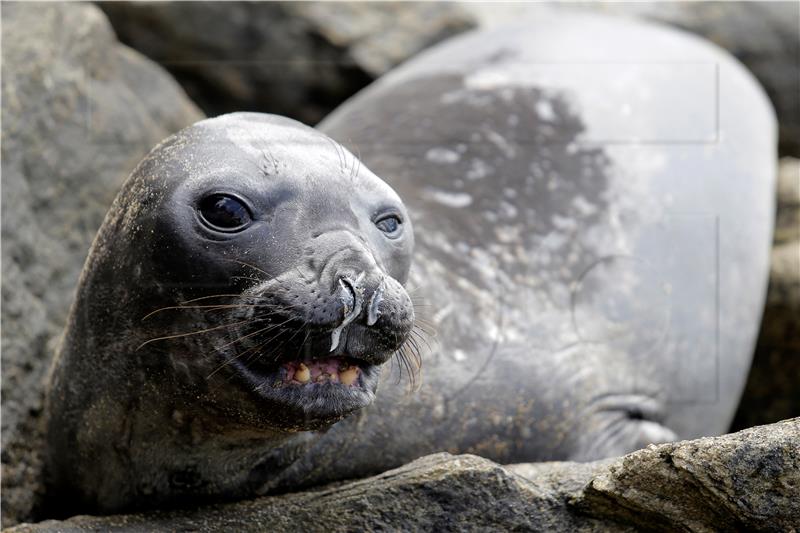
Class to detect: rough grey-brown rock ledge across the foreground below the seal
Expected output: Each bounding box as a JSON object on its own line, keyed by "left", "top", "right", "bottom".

{"left": 9, "top": 419, "right": 800, "bottom": 533}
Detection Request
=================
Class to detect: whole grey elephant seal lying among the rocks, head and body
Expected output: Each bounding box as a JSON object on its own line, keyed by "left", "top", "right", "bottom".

{"left": 42, "top": 12, "right": 776, "bottom": 511}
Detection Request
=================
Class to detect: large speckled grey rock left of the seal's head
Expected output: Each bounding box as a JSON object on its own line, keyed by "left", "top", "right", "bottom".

{"left": 2, "top": 3, "right": 202, "bottom": 525}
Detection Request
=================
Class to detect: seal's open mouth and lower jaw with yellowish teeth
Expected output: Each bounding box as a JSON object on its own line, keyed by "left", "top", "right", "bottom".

{"left": 230, "top": 355, "right": 380, "bottom": 430}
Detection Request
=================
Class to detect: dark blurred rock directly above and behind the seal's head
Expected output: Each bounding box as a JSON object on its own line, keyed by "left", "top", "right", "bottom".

{"left": 100, "top": 2, "right": 473, "bottom": 124}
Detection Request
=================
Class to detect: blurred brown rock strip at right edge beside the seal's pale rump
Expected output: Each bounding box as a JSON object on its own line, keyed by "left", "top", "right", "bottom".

{"left": 734, "top": 157, "right": 800, "bottom": 428}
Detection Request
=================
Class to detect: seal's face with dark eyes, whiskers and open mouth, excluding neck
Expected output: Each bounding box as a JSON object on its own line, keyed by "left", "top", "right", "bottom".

{"left": 145, "top": 114, "right": 414, "bottom": 429}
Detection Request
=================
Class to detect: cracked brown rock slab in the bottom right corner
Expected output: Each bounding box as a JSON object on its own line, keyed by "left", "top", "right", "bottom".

{"left": 575, "top": 418, "right": 800, "bottom": 531}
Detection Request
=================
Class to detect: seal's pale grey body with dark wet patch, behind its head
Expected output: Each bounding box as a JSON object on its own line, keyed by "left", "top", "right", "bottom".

{"left": 288, "top": 11, "right": 776, "bottom": 478}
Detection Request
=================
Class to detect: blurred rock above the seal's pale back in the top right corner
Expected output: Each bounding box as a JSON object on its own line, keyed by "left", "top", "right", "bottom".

{"left": 466, "top": 2, "right": 800, "bottom": 157}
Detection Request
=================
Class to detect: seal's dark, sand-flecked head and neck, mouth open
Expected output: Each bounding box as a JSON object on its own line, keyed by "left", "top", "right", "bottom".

{"left": 47, "top": 113, "right": 418, "bottom": 514}
